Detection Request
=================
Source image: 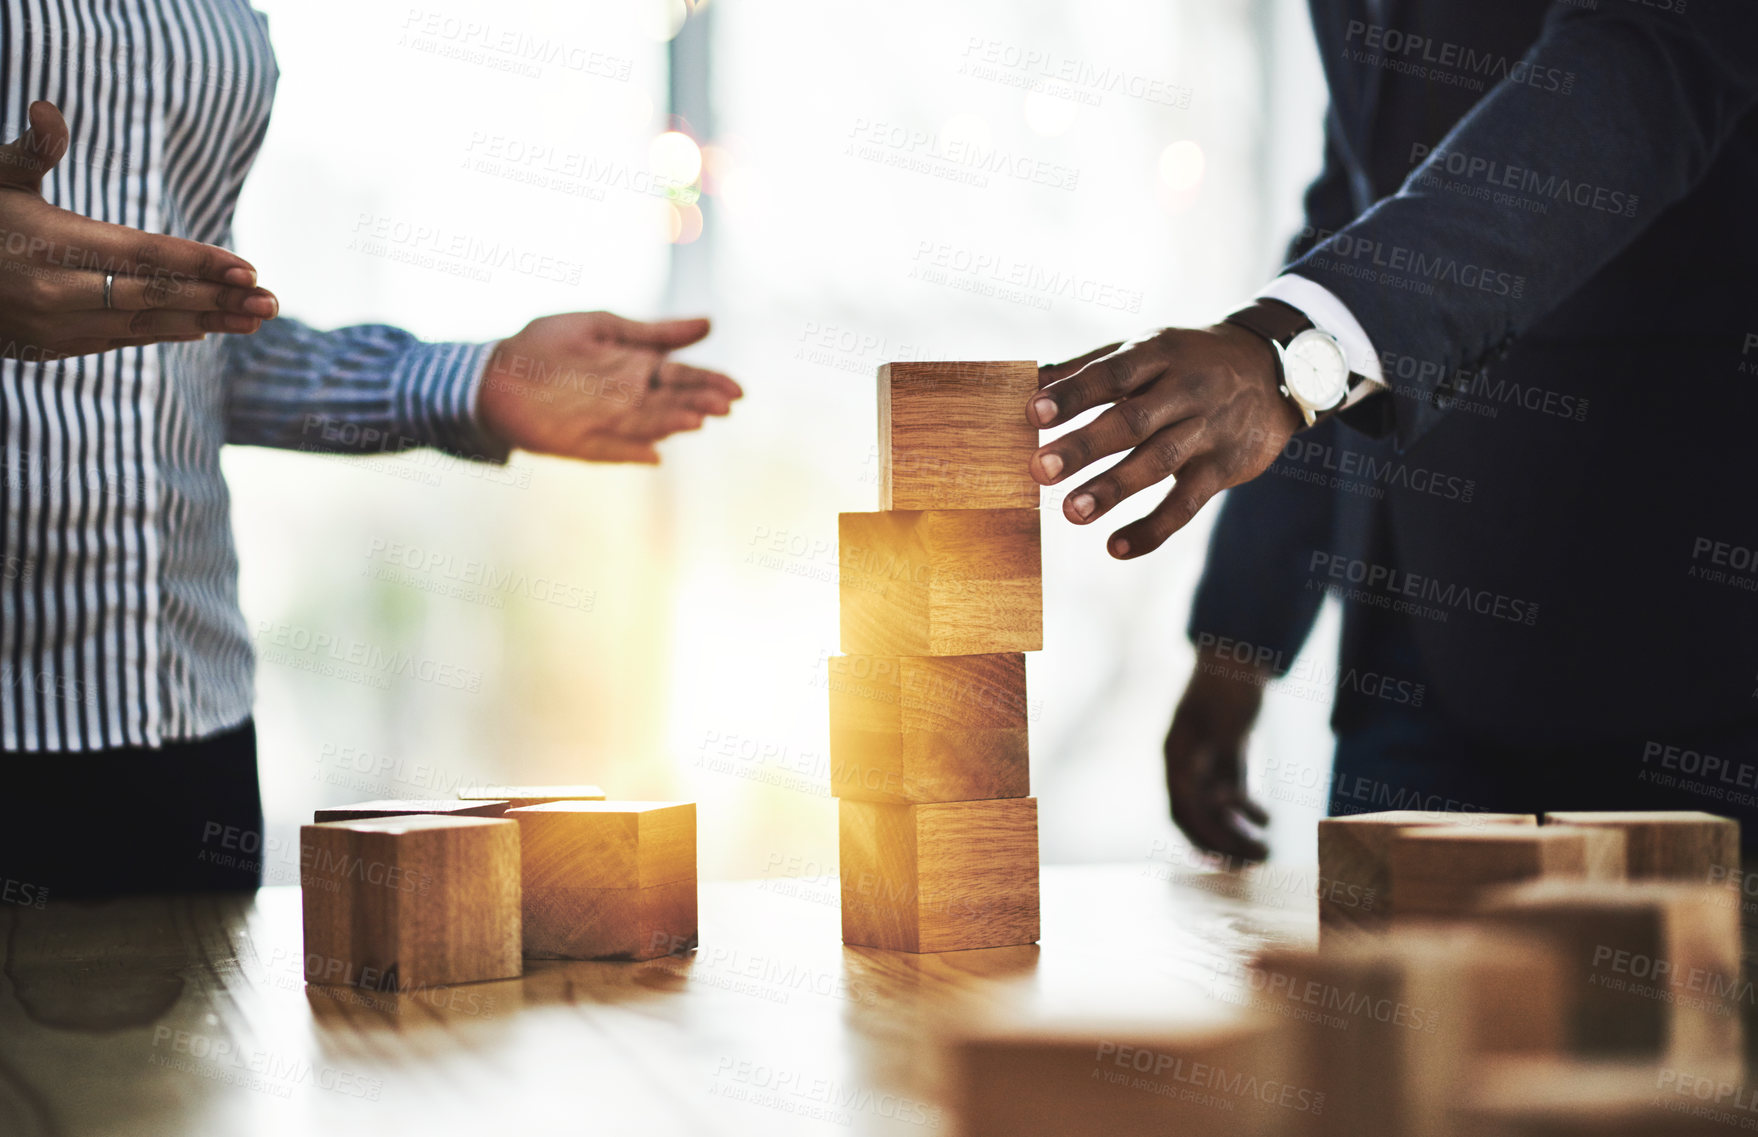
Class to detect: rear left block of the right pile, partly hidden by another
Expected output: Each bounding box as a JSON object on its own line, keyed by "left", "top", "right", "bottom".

{"left": 1319, "top": 810, "right": 1538, "bottom": 944}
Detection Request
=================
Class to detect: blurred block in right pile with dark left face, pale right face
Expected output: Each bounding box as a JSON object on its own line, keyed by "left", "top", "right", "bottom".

{"left": 1480, "top": 880, "right": 1753, "bottom": 1065}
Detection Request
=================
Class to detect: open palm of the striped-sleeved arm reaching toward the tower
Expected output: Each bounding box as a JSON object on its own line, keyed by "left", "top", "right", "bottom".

{"left": 478, "top": 311, "right": 744, "bottom": 464}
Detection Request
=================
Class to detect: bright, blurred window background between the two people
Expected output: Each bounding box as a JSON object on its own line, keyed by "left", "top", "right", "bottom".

{"left": 225, "top": 0, "right": 1334, "bottom": 882}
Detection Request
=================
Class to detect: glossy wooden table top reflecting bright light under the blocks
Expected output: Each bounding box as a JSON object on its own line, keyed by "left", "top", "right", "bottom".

{"left": 0, "top": 863, "right": 1317, "bottom": 1137}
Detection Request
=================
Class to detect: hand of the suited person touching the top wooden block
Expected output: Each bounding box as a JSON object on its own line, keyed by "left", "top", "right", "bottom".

{"left": 1027, "top": 323, "right": 1303, "bottom": 561}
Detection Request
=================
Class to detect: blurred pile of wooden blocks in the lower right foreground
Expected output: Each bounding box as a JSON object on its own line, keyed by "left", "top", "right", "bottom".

{"left": 956, "top": 812, "right": 1758, "bottom": 1137}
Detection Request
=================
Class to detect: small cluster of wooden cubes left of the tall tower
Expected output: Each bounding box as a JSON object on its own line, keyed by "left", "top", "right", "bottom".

{"left": 299, "top": 786, "right": 696, "bottom": 991}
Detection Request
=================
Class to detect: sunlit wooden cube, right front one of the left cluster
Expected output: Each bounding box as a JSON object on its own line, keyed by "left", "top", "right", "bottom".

{"left": 506, "top": 801, "right": 696, "bottom": 960}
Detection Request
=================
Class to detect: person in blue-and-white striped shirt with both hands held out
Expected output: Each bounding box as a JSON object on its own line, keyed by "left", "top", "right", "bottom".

{"left": 0, "top": 0, "right": 742, "bottom": 896}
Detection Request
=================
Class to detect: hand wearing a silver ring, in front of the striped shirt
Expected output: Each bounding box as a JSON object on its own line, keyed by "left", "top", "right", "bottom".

{"left": 0, "top": 102, "right": 280, "bottom": 362}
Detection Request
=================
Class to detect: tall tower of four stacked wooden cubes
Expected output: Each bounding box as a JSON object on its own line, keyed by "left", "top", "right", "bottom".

{"left": 830, "top": 362, "right": 1042, "bottom": 952}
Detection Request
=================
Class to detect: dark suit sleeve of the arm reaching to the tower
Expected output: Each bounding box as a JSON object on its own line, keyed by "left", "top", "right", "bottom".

{"left": 1289, "top": 0, "right": 1758, "bottom": 448}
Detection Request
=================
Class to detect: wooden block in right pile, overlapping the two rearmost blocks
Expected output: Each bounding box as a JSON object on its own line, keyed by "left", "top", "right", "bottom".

{"left": 1387, "top": 826, "right": 1616, "bottom": 923}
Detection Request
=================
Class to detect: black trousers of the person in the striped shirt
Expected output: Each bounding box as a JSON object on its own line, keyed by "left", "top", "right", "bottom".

{"left": 0, "top": 722, "right": 262, "bottom": 905}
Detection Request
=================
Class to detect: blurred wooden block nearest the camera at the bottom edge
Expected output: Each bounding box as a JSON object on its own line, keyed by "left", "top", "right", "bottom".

{"left": 951, "top": 1018, "right": 1300, "bottom": 1137}
